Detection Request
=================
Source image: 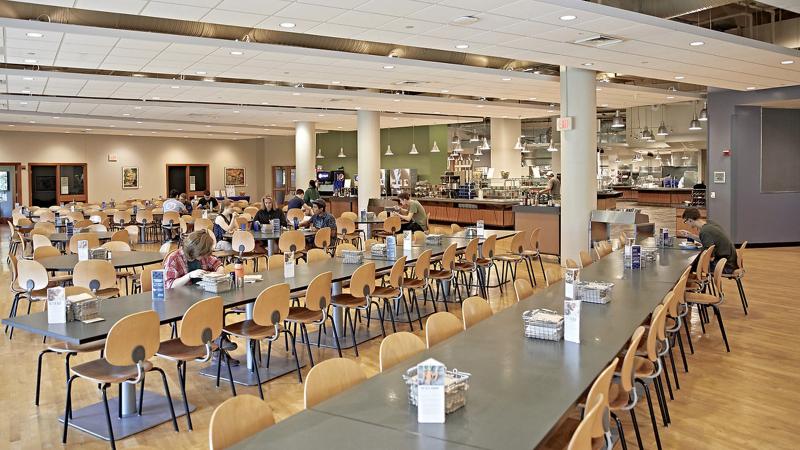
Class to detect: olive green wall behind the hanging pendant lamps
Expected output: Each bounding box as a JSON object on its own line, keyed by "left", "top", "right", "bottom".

{"left": 316, "top": 125, "right": 449, "bottom": 184}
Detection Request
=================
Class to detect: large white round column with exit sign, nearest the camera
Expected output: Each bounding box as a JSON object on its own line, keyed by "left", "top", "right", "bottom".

{"left": 560, "top": 66, "right": 597, "bottom": 260}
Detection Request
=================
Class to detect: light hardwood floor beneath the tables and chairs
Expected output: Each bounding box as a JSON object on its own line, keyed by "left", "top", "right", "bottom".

{"left": 0, "top": 229, "right": 800, "bottom": 450}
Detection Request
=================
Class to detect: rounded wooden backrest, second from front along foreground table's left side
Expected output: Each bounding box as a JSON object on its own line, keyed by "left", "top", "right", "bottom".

{"left": 303, "top": 358, "right": 367, "bottom": 409}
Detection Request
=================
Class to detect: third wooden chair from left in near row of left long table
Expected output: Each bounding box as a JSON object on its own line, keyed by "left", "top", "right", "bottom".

{"left": 225, "top": 283, "right": 300, "bottom": 400}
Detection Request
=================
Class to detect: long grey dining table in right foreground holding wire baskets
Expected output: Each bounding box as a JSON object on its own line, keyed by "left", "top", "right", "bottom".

{"left": 235, "top": 246, "right": 697, "bottom": 450}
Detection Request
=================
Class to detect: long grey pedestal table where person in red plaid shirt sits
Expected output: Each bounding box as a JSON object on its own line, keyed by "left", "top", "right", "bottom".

{"left": 2, "top": 230, "right": 515, "bottom": 440}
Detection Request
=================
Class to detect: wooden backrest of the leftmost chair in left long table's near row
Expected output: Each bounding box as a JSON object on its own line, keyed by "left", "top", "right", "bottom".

{"left": 104, "top": 312, "right": 160, "bottom": 366}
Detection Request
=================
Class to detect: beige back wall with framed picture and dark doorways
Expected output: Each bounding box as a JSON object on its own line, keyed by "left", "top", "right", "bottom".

{"left": 0, "top": 132, "right": 294, "bottom": 203}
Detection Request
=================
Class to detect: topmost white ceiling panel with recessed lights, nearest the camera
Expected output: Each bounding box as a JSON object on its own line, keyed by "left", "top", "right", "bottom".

{"left": 15, "top": 0, "right": 800, "bottom": 92}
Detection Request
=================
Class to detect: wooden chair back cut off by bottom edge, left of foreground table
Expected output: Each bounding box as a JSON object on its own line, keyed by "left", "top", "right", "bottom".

{"left": 208, "top": 395, "right": 275, "bottom": 450}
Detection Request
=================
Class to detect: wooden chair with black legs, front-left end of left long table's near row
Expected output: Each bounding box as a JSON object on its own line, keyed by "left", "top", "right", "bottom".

{"left": 61, "top": 310, "right": 178, "bottom": 449}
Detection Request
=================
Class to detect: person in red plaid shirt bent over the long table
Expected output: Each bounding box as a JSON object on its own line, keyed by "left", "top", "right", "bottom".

{"left": 164, "top": 230, "right": 225, "bottom": 289}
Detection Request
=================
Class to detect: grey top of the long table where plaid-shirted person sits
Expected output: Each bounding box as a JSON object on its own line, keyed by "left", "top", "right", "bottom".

{"left": 2, "top": 230, "right": 516, "bottom": 344}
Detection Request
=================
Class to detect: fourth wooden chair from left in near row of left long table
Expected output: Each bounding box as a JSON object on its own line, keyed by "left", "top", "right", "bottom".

{"left": 285, "top": 272, "right": 338, "bottom": 370}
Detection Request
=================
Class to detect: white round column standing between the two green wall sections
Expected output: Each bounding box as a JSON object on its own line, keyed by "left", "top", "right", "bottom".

{"left": 358, "top": 111, "right": 381, "bottom": 211}
